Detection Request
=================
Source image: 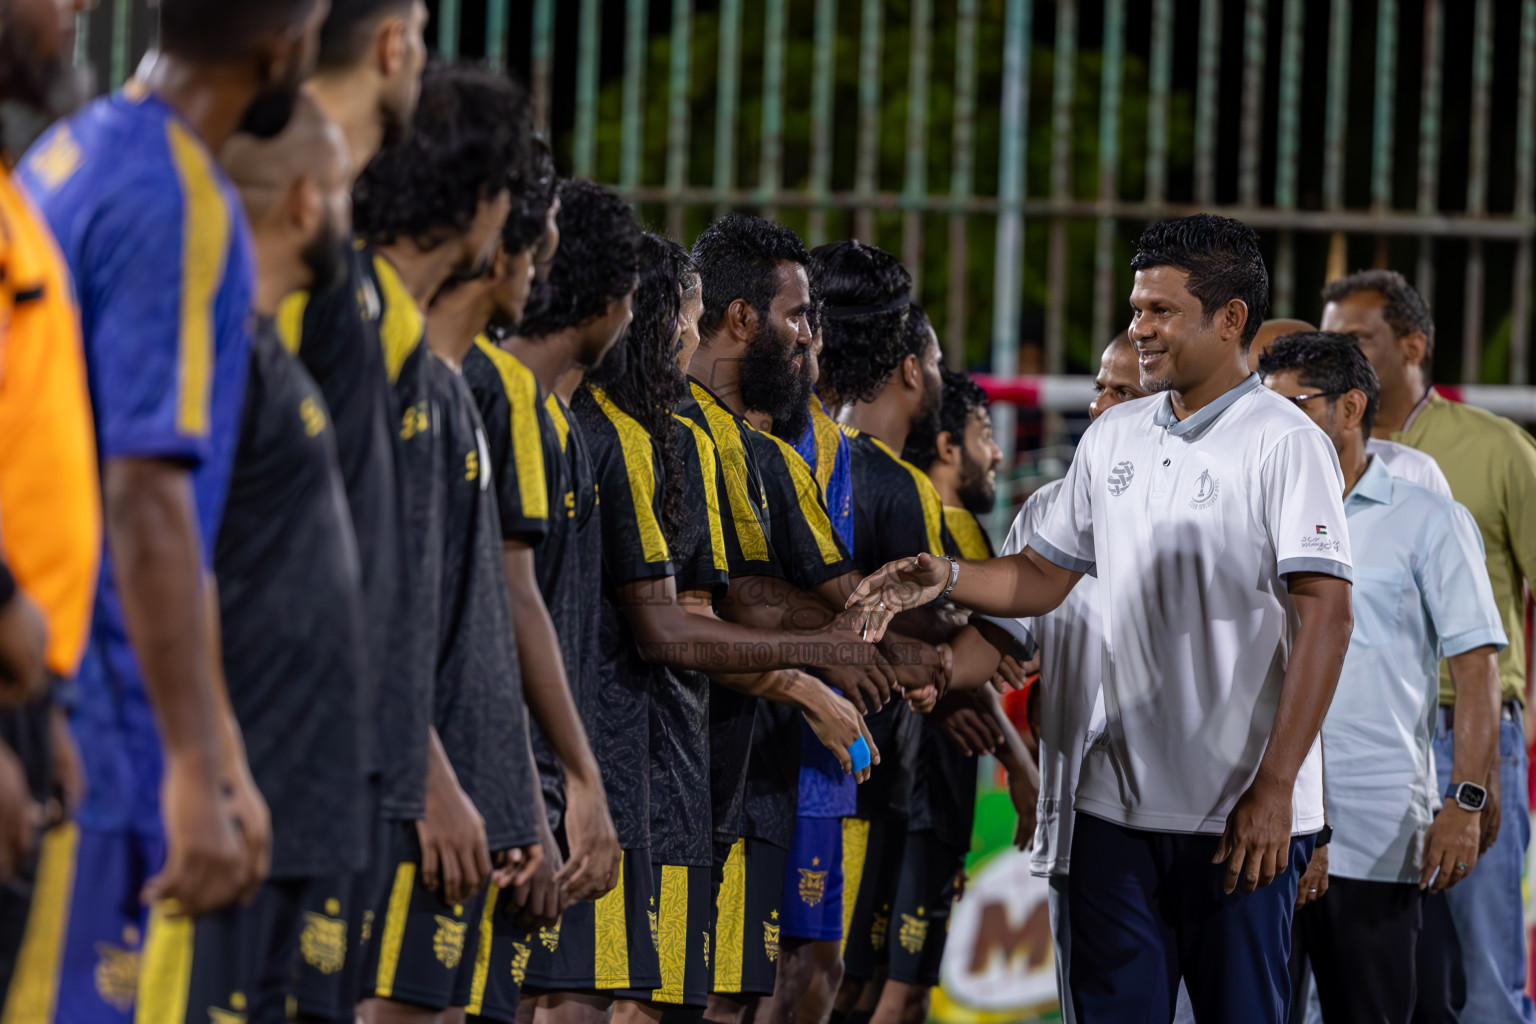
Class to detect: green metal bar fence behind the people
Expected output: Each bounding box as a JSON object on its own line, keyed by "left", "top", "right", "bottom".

{"left": 81, "top": 0, "right": 1536, "bottom": 384}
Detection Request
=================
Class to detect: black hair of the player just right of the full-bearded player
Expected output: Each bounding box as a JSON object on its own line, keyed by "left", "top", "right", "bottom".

{"left": 811, "top": 239, "right": 912, "bottom": 402}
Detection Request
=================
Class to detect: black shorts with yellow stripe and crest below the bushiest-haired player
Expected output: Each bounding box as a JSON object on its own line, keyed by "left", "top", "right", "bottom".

{"left": 362, "top": 821, "right": 485, "bottom": 1010}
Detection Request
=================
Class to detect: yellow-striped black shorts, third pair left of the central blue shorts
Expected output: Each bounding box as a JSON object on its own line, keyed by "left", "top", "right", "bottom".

{"left": 524, "top": 847, "right": 662, "bottom": 992}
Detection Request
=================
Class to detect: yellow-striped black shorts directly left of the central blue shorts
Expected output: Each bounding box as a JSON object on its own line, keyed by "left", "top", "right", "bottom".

{"left": 710, "top": 838, "right": 790, "bottom": 995}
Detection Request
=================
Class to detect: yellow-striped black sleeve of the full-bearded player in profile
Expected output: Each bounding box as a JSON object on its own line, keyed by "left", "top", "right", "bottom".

{"left": 748, "top": 430, "right": 854, "bottom": 590}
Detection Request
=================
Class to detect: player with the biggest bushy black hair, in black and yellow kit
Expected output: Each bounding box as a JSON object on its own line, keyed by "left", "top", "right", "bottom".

{"left": 353, "top": 68, "right": 547, "bottom": 1021}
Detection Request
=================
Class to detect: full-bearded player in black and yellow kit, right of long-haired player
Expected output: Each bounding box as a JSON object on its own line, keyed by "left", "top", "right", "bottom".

{"left": 682, "top": 215, "right": 938, "bottom": 1019}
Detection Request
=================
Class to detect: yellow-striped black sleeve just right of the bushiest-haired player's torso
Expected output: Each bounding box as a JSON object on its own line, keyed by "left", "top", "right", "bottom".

{"left": 464, "top": 338, "right": 553, "bottom": 543}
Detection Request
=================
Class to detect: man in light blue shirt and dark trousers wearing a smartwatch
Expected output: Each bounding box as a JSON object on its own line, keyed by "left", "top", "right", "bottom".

{"left": 1260, "top": 332, "right": 1507, "bottom": 1024}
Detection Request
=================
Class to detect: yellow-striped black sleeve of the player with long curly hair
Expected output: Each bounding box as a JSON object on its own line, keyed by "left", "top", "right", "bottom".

{"left": 571, "top": 388, "right": 676, "bottom": 586}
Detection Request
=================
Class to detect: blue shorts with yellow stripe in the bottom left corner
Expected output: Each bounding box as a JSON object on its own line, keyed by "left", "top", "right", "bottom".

{"left": 2, "top": 823, "right": 166, "bottom": 1024}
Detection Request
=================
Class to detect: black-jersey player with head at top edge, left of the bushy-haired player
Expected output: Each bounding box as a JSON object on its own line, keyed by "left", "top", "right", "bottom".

{"left": 278, "top": 0, "right": 436, "bottom": 1022}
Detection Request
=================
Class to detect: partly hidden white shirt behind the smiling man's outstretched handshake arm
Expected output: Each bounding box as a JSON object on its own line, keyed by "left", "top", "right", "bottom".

{"left": 1003, "top": 481, "right": 1104, "bottom": 875}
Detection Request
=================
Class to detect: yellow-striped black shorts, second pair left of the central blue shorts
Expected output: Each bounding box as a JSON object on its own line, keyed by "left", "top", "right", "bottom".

{"left": 613, "top": 864, "right": 714, "bottom": 1009}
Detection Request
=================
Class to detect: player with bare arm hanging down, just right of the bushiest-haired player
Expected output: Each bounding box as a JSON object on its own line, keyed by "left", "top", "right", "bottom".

{"left": 439, "top": 161, "right": 634, "bottom": 1022}
